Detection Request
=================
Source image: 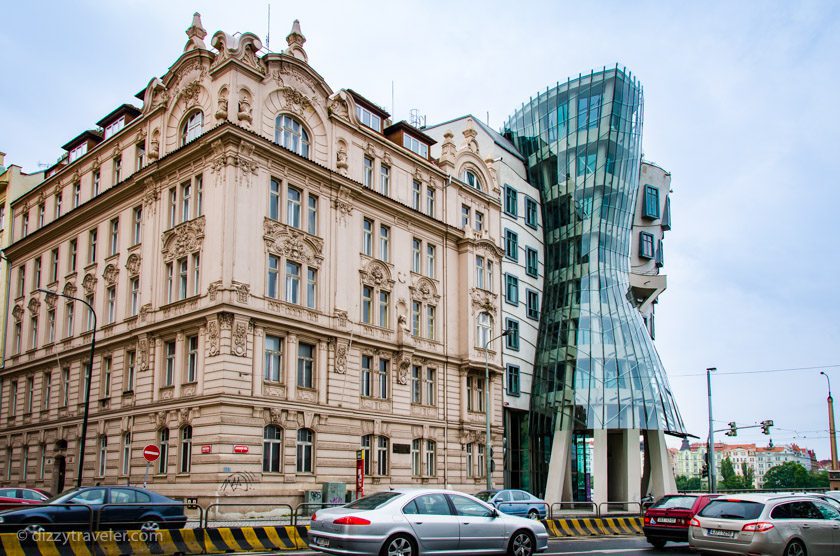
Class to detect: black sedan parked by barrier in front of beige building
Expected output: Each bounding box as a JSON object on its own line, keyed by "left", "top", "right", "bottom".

{"left": 0, "top": 486, "right": 187, "bottom": 532}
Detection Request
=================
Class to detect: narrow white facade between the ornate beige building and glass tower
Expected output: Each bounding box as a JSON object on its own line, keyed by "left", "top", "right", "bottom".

{"left": 423, "top": 116, "right": 544, "bottom": 489}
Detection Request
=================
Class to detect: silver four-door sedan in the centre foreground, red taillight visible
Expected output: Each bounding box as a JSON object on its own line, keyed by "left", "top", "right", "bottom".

{"left": 309, "top": 489, "right": 548, "bottom": 556}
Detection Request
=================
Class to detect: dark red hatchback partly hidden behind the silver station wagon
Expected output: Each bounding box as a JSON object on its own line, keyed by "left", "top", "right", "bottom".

{"left": 644, "top": 494, "right": 720, "bottom": 548}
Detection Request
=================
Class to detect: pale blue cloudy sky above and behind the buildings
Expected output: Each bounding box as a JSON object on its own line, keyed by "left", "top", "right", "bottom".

{"left": 0, "top": 0, "right": 840, "bottom": 459}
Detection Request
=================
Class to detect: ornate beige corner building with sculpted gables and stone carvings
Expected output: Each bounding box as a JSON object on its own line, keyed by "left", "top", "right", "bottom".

{"left": 0, "top": 15, "right": 503, "bottom": 502}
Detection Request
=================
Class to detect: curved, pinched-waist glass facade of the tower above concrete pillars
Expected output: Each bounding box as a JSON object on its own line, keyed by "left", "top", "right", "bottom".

{"left": 505, "top": 68, "right": 683, "bottom": 489}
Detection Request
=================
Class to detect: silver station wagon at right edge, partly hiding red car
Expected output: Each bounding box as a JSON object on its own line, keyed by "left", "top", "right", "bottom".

{"left": 688, "top": 494, "right": 840, "bottom": 556}
